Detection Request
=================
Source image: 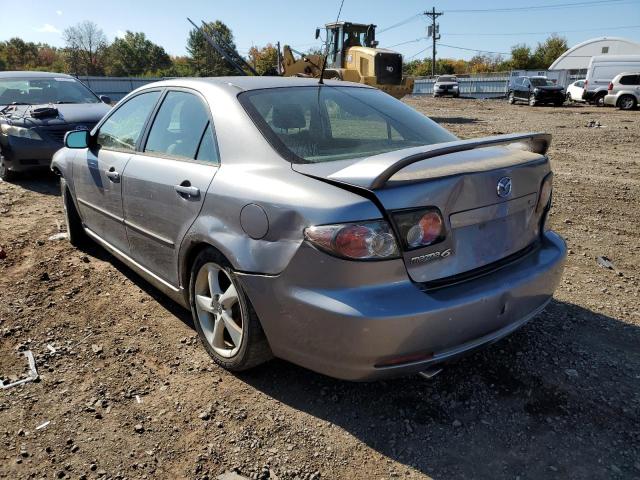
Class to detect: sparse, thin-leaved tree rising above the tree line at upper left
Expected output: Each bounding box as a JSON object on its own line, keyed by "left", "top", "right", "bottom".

{"left": 62, "top": 20, "right": 107, "bottom": 75}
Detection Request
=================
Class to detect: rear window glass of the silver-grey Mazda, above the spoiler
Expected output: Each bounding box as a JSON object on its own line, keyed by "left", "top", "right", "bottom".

{"left": 238, "top": 85, "right": 457, "bottom": 163}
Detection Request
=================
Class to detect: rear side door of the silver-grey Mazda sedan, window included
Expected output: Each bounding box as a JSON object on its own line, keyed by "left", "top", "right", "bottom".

{"left": 123, "top": 89, "right": 219, "bottom": 287}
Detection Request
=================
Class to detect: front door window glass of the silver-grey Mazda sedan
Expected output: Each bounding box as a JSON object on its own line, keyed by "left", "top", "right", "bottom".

{"left": 98, "top": 91, "right": 160, "bottom": 151}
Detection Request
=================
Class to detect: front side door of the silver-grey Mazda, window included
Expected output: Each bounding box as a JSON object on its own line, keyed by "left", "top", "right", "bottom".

{"left": 73, "top": 90, "right": 160, "bottom": 253}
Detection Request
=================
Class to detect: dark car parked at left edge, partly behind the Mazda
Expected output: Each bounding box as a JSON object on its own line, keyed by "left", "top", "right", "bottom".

{"left": 0, "top": 72, "right": 110, "bottom": 181}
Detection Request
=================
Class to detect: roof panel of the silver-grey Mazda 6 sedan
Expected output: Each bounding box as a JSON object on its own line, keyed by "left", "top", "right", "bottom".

{"left": 142, "top": 76, "right": 373, "bottom": 94}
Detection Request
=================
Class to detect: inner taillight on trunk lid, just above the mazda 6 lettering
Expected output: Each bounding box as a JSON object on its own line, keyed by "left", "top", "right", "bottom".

{"left": 393, "top": 208, "right": 445, "bottom": 250}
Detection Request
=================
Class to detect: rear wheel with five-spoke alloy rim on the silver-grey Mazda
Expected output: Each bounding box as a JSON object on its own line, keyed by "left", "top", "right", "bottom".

{"left": 189, "top": 248, "right": 273, "bottom": 372}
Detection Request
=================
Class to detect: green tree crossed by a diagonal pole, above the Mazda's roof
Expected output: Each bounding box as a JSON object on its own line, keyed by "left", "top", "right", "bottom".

{"left": 187, "top": 20, "right": 237, "bottom": 77}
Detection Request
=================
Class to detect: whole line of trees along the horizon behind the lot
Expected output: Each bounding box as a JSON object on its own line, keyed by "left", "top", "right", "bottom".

{"left": 0, "top": 20, "right": 568, "bottom": 77}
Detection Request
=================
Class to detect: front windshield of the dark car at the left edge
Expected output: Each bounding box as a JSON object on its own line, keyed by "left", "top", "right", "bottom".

{"left": 0, "top": 77, "right": 100, "bottom": 105}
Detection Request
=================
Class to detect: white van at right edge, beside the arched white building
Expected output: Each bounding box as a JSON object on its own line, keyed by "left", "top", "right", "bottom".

{"left": 582, "top": 55, "right": 640, "bottom": 105}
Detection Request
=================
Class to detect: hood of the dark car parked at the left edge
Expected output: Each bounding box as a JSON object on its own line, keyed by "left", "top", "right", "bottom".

{"left": 4, "top": 103, "right": 111, "bottom": 126}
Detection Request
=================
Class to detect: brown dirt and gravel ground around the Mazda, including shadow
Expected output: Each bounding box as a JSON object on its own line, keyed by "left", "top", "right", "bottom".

{"left": 0, "top": 98, "right": 640, "bottom": 480}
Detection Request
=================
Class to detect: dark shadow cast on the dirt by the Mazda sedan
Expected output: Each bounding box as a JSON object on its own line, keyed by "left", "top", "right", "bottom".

{"left": 77, "top": 246, "right": 640, "bottom": 480}
